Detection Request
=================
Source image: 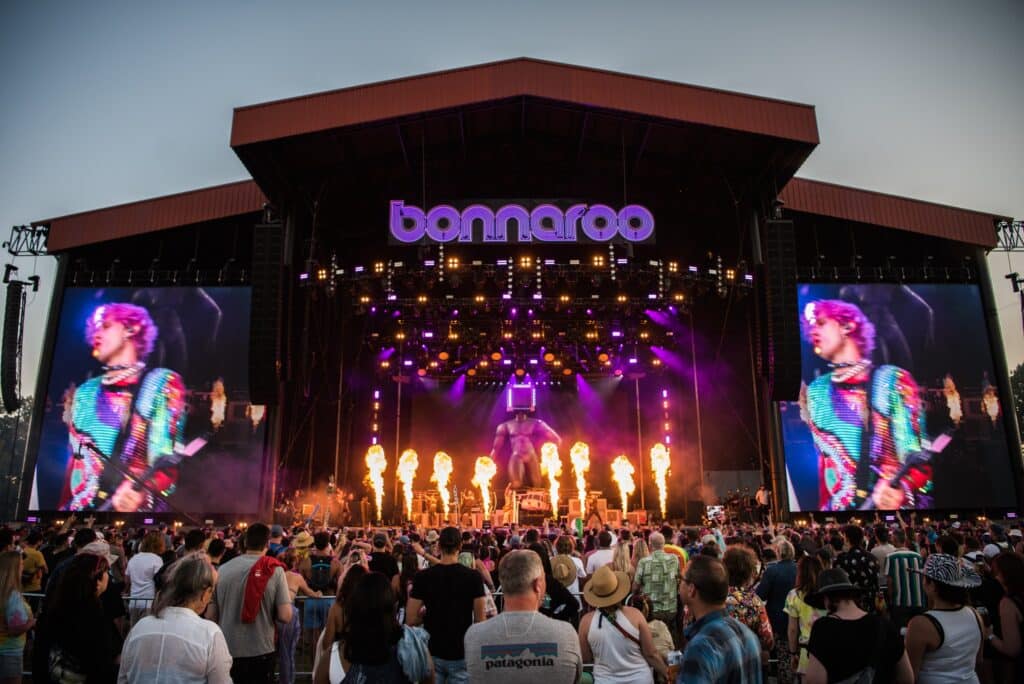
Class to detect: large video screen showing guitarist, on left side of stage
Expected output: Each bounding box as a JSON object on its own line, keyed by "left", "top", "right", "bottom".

{"left": 30, "top": 287, "right": 266, "bottom": 515}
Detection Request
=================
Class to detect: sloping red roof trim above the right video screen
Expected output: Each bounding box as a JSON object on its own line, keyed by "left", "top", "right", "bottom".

{"left": 779, "top": 178, "right": 1004, "bottom": 249}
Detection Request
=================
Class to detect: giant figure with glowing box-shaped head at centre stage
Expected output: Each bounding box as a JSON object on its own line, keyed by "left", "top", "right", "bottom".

{"left": 490, "top": 385, "right": 562, "bottom": 489}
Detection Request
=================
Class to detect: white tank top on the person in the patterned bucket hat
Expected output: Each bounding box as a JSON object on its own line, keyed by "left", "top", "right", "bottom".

{"left": 918, "top": 606, "right": 981, "bottom": 684}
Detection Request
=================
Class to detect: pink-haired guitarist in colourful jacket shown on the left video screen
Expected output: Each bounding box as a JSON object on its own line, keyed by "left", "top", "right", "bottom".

{"left": 59, "top": 303, "right": 185, "bottom": 512}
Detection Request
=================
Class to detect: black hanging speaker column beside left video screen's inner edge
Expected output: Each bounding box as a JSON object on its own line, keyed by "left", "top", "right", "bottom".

{"left": 249, "top": 223, "right": 283, "bottom": 405}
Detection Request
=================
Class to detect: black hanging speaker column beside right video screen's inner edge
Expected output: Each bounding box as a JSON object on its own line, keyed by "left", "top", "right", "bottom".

{"left": 761, "top": 220, "right": 801, "bottom": 401}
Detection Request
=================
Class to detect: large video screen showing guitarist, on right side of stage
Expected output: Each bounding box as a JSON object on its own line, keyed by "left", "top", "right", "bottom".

{"left": 778, "top": 284, "right": 1016, "bottom": 511}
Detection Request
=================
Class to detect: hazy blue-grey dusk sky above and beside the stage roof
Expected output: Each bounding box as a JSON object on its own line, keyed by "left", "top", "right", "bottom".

{"left": 0, "top": 0, "right": 1024, "bottom": 394}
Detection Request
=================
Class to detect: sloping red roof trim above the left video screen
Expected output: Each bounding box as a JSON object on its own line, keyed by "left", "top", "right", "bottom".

{"left": 40, "top": 180, "right": 267, "bottom": 253}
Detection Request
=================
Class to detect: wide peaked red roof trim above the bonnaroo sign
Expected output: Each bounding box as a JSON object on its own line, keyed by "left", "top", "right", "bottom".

{"left": 231, "top": 57, "right": 819, "bottom": 147}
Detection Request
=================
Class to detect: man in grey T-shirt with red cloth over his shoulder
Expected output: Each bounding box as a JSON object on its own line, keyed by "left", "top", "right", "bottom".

{"left": 210, "top": 522, "right": 293, "bottom": 684}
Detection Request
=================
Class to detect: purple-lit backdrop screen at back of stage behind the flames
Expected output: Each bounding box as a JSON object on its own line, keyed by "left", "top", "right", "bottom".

{"left": 409, "top": 376, "right": 663, "bottom": 501}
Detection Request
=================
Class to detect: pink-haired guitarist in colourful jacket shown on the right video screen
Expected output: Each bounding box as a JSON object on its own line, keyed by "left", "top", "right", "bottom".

{"left": 802, "top": 300, "right": 932, "bottom": 511}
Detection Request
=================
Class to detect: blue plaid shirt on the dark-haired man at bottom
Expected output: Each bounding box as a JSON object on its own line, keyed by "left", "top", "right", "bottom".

{"left": 676, "top": 610, "right": 762, "bottom": 684}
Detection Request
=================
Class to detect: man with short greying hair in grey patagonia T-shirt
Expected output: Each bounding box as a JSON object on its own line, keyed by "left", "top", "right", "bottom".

{"left": 465, "top": 551, "right": 583, "bottom": 684}
